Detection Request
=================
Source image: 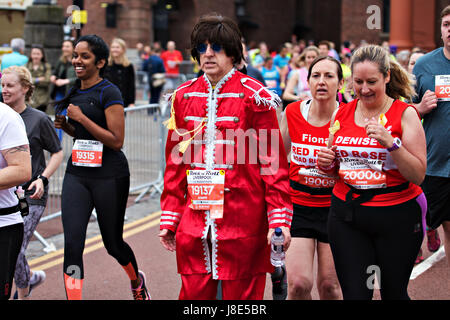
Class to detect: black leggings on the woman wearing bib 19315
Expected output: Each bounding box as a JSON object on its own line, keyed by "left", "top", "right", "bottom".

{"left": 61, "top": 173, "right": 138, "bottom": 279}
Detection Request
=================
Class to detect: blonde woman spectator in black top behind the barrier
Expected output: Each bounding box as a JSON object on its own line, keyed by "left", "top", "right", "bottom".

{"left": 105, "top": 38, "right": 136, "bottom": 108}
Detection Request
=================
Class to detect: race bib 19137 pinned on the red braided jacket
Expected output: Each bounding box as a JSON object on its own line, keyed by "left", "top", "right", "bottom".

{"left": 186, "top": 170, "right": 225, "bottom": 219}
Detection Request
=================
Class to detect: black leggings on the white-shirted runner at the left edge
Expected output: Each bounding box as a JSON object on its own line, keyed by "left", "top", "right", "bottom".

{"left": 0, "top": 223, "right": 23, "bottom": 300}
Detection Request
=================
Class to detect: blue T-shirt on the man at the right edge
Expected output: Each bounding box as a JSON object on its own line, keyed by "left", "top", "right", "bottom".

{"left": 413, "top": 48, "right": 450, "bottom": 178}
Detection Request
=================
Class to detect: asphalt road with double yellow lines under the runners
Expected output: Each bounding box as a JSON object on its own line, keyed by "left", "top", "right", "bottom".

{"left": 15, "top": 195, "right": 450, "bottom": 300}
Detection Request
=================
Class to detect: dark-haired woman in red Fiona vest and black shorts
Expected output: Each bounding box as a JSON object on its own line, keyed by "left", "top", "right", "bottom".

{"left": 281, "top": 56, "right": 343, "bottom": 300}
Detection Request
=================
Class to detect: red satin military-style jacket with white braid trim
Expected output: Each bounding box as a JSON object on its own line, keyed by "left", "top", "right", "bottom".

{"left": 160, "top": 69, "right": 292, "bottom": 280}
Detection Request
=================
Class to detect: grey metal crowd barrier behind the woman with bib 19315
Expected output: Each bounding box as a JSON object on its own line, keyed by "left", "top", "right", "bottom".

{"left": 34, "top": 102, "right": 167, "bottom": 252}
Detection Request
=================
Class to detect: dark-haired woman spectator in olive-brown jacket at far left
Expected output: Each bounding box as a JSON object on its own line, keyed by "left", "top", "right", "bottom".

{"left": 26, "top": 45, "right": 52, "bottom": 112}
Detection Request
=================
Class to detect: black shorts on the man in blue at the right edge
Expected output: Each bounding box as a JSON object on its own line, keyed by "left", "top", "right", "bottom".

{"left": 422, "top": 176, "right": 450, "bottom": 229}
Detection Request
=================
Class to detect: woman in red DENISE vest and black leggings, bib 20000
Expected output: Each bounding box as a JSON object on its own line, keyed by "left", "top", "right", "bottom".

{"left": 318, "top": 45, "right": 427, "bottom": 299}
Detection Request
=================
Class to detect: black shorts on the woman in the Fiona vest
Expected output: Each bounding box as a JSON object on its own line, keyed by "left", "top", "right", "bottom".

{"left": 291, "top": 203, "right": 330, "bottom": 243}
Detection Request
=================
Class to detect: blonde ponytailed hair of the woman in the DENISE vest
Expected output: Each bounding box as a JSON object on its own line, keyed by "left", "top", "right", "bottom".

{"left": 350, "top": 45, "right": 416, "bottom": 101}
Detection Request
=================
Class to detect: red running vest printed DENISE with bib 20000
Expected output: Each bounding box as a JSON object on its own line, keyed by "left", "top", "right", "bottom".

{"left": 333, "top": 100, "right": 422, "bottom": 206}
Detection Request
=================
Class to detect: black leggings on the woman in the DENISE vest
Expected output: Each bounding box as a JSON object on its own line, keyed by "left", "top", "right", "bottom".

{"left": 328, "top": 195, "right": 426, "bottom": 300}
